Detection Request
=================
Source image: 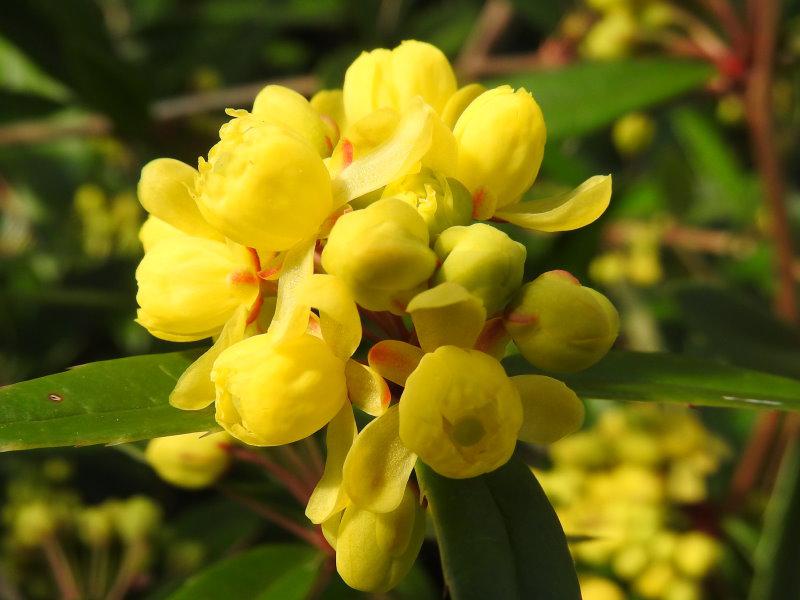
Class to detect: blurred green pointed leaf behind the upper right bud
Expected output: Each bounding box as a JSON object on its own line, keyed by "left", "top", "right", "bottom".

{"left": 488, "top": 58, "right": 713, "bottom": 141}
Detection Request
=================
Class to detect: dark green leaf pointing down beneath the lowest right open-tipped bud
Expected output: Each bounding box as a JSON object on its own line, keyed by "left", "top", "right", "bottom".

{"left": 417, "top": 457, "right": 580, "bottom": 600}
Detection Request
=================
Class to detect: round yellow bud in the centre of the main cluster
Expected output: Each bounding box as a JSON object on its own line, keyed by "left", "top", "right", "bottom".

{"left": 322, "top": 198, "right": 436, "bottom": 314}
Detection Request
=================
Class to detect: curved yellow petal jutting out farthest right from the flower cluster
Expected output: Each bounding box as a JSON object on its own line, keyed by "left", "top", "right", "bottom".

{"left": 494, "top": 175, "right": 611, "bottom": 231}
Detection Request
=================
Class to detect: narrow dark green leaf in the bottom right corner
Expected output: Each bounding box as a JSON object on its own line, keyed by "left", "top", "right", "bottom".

{"left": 748, "top": 441, "right": 800, "bottom": 600}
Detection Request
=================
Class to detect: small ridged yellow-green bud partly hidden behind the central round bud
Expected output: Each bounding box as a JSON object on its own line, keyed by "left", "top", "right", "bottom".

{"left": 383, "top": 168, "right": 472, "bottom": 239}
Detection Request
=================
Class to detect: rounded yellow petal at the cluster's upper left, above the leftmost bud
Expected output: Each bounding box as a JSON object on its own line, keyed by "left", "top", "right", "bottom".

{"left": 136, "top": 158, "right": 222, "bottom": 240}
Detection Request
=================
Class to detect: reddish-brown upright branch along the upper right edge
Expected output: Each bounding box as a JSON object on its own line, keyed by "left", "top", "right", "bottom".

{"left": 745, "top": 0, "right": 798, "bottom": 323}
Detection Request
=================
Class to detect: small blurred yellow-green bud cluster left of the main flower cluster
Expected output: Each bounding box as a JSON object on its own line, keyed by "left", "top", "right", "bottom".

{"left": 74, "top": 183, "right": 142, "bottom": 260}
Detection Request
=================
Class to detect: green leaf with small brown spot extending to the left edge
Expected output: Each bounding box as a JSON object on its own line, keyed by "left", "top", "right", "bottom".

{"left": 0, "top": 352, "right": 217, "bottom": 451}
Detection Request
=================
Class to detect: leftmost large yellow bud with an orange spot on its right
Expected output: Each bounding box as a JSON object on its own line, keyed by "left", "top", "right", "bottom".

{"left": 136, "top": 235, "right": 259, "bottom": 342}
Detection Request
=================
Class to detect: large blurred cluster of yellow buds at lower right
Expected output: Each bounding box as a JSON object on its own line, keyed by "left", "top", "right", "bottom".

{"left": 537, "top": 406, "right": 727, "bottom": 600}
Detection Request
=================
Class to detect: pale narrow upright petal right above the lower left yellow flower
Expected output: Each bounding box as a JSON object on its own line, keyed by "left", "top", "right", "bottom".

{"left": 269, "top": 239, "right": 316, "bottom": 339}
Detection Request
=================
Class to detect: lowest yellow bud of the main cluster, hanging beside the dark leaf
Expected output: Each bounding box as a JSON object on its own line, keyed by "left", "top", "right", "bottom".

{"left": 336, "top": 488, "right": 425, "bottom": 593}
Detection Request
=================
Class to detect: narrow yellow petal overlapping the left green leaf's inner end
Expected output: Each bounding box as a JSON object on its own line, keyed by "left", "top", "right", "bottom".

{"left": 169, "top": 306, "right": 248, "bottom": 410}
